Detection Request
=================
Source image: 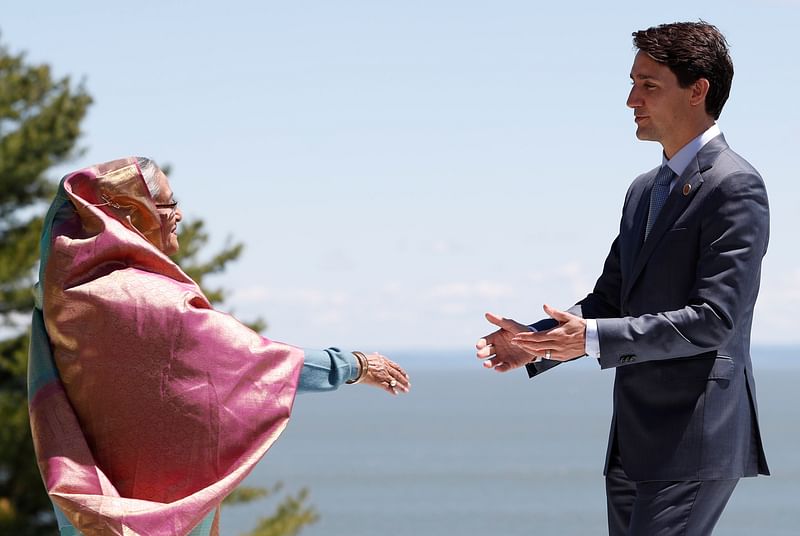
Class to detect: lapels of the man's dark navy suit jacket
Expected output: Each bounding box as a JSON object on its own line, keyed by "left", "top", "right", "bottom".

{"left": 622, "top": 135, "right": 728, "bottom": 303}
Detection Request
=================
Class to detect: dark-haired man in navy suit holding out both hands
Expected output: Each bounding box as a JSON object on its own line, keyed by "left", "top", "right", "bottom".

{"left": 477, "top": 22, "right": 769, "bottom": 536}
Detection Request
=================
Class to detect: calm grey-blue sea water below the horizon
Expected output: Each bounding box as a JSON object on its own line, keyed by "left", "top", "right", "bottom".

{"left": 222, "top": 351, "right": 800, "bottom": 536}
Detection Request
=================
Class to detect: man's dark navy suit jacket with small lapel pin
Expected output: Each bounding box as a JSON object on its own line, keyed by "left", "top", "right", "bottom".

{"left": 528, "top": 135, "right": 769, "bottom": 481}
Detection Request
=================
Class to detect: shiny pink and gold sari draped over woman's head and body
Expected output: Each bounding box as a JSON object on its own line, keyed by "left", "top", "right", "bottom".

{"left": 28, "top": 158, "right": 303, "bottom": 536}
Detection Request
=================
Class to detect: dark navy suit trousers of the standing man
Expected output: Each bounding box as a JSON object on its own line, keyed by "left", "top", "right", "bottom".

{"left": 606, "top": 448, "right": 739, "bottom": 536}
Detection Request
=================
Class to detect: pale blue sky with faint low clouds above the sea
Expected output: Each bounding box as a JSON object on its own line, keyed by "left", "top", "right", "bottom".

{"left": 0, "top": 0, "right": 800, "bottom": 351}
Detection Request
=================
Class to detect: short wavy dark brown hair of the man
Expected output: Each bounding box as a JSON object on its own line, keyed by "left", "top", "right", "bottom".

{"left": 632, "top": 21, "right": 733, "bottom": 119}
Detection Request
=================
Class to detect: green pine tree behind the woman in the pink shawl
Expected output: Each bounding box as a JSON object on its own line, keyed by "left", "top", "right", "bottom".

{"left": 0, "top": 38, "right": 317, "bottom": 536}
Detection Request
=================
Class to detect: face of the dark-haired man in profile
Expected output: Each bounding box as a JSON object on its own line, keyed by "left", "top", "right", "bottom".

{"left": 627, "top": 51, "right": 697, "bottom": 157}
